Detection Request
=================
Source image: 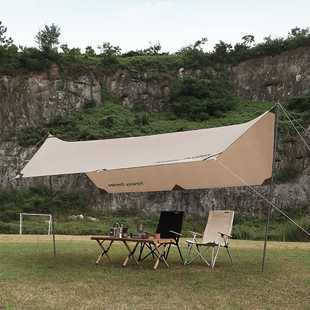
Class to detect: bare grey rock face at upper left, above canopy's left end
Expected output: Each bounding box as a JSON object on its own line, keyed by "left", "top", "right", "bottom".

{"left": 0, "top": 66, "right": 101, "bottom": 136}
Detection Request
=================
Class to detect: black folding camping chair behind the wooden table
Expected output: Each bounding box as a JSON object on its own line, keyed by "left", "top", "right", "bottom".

{"left": 139, "top": 211, "right": 184, "bottom": 263}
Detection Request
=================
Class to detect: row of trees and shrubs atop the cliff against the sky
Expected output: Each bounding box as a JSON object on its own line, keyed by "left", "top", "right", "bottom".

{"left": 0, "top": 21, "right": 310, "bottom": 74}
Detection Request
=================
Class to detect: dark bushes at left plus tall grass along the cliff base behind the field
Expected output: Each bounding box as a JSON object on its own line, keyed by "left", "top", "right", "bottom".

{"left": 0, "top": 186, "right": 310, "bottom": 241}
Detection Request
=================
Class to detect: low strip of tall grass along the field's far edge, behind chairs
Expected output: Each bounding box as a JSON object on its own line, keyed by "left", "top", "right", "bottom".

{"left": 0, "top": 213, "right": 310, "bottom": 241}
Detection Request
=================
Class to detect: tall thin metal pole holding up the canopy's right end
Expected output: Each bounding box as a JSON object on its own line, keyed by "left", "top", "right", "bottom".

{"left": 262, "top": 103, "right": 279, "bottom": 272}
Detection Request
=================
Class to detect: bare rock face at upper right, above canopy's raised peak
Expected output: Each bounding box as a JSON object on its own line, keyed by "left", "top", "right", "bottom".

{"left": 231, "top": 47, "right": 310, "bottom": 101}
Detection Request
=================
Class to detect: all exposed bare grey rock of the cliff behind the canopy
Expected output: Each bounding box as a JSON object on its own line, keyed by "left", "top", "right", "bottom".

{"left": 0, "top": 48, "right": 310, "bottom": 215}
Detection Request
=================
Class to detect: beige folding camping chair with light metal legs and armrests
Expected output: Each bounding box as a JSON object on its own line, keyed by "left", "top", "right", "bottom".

{"left": 185, "top": 210, "right": 234, "bottom": 268}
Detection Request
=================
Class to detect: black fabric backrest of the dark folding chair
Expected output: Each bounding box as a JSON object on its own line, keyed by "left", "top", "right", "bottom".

{"left": 156, "top": 211, "right": 184, "bottom": 239}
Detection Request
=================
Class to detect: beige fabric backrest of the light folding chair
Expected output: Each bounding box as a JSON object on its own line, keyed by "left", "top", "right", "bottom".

{"left": 203, "top": 210, "right": 234, "bottom": 244}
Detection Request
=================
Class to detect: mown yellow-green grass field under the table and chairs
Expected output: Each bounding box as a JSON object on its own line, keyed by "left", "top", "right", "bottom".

{"left": 0, "top": 235, "right": 310, "bottom": 310}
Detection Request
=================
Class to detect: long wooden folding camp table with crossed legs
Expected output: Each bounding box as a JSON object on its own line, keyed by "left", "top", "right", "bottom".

{"left": 91, "top": 236, "right": 174, "bottom": 270}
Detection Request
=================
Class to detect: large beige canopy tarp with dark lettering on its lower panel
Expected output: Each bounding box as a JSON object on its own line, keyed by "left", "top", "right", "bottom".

{"left": 21, "top": 112, "right": 275, "bottom": 193}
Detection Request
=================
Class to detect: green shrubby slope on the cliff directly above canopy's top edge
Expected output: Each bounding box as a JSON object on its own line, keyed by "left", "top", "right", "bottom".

{"left": 13, "top": 101, "right": 272, "bottom": 147}
